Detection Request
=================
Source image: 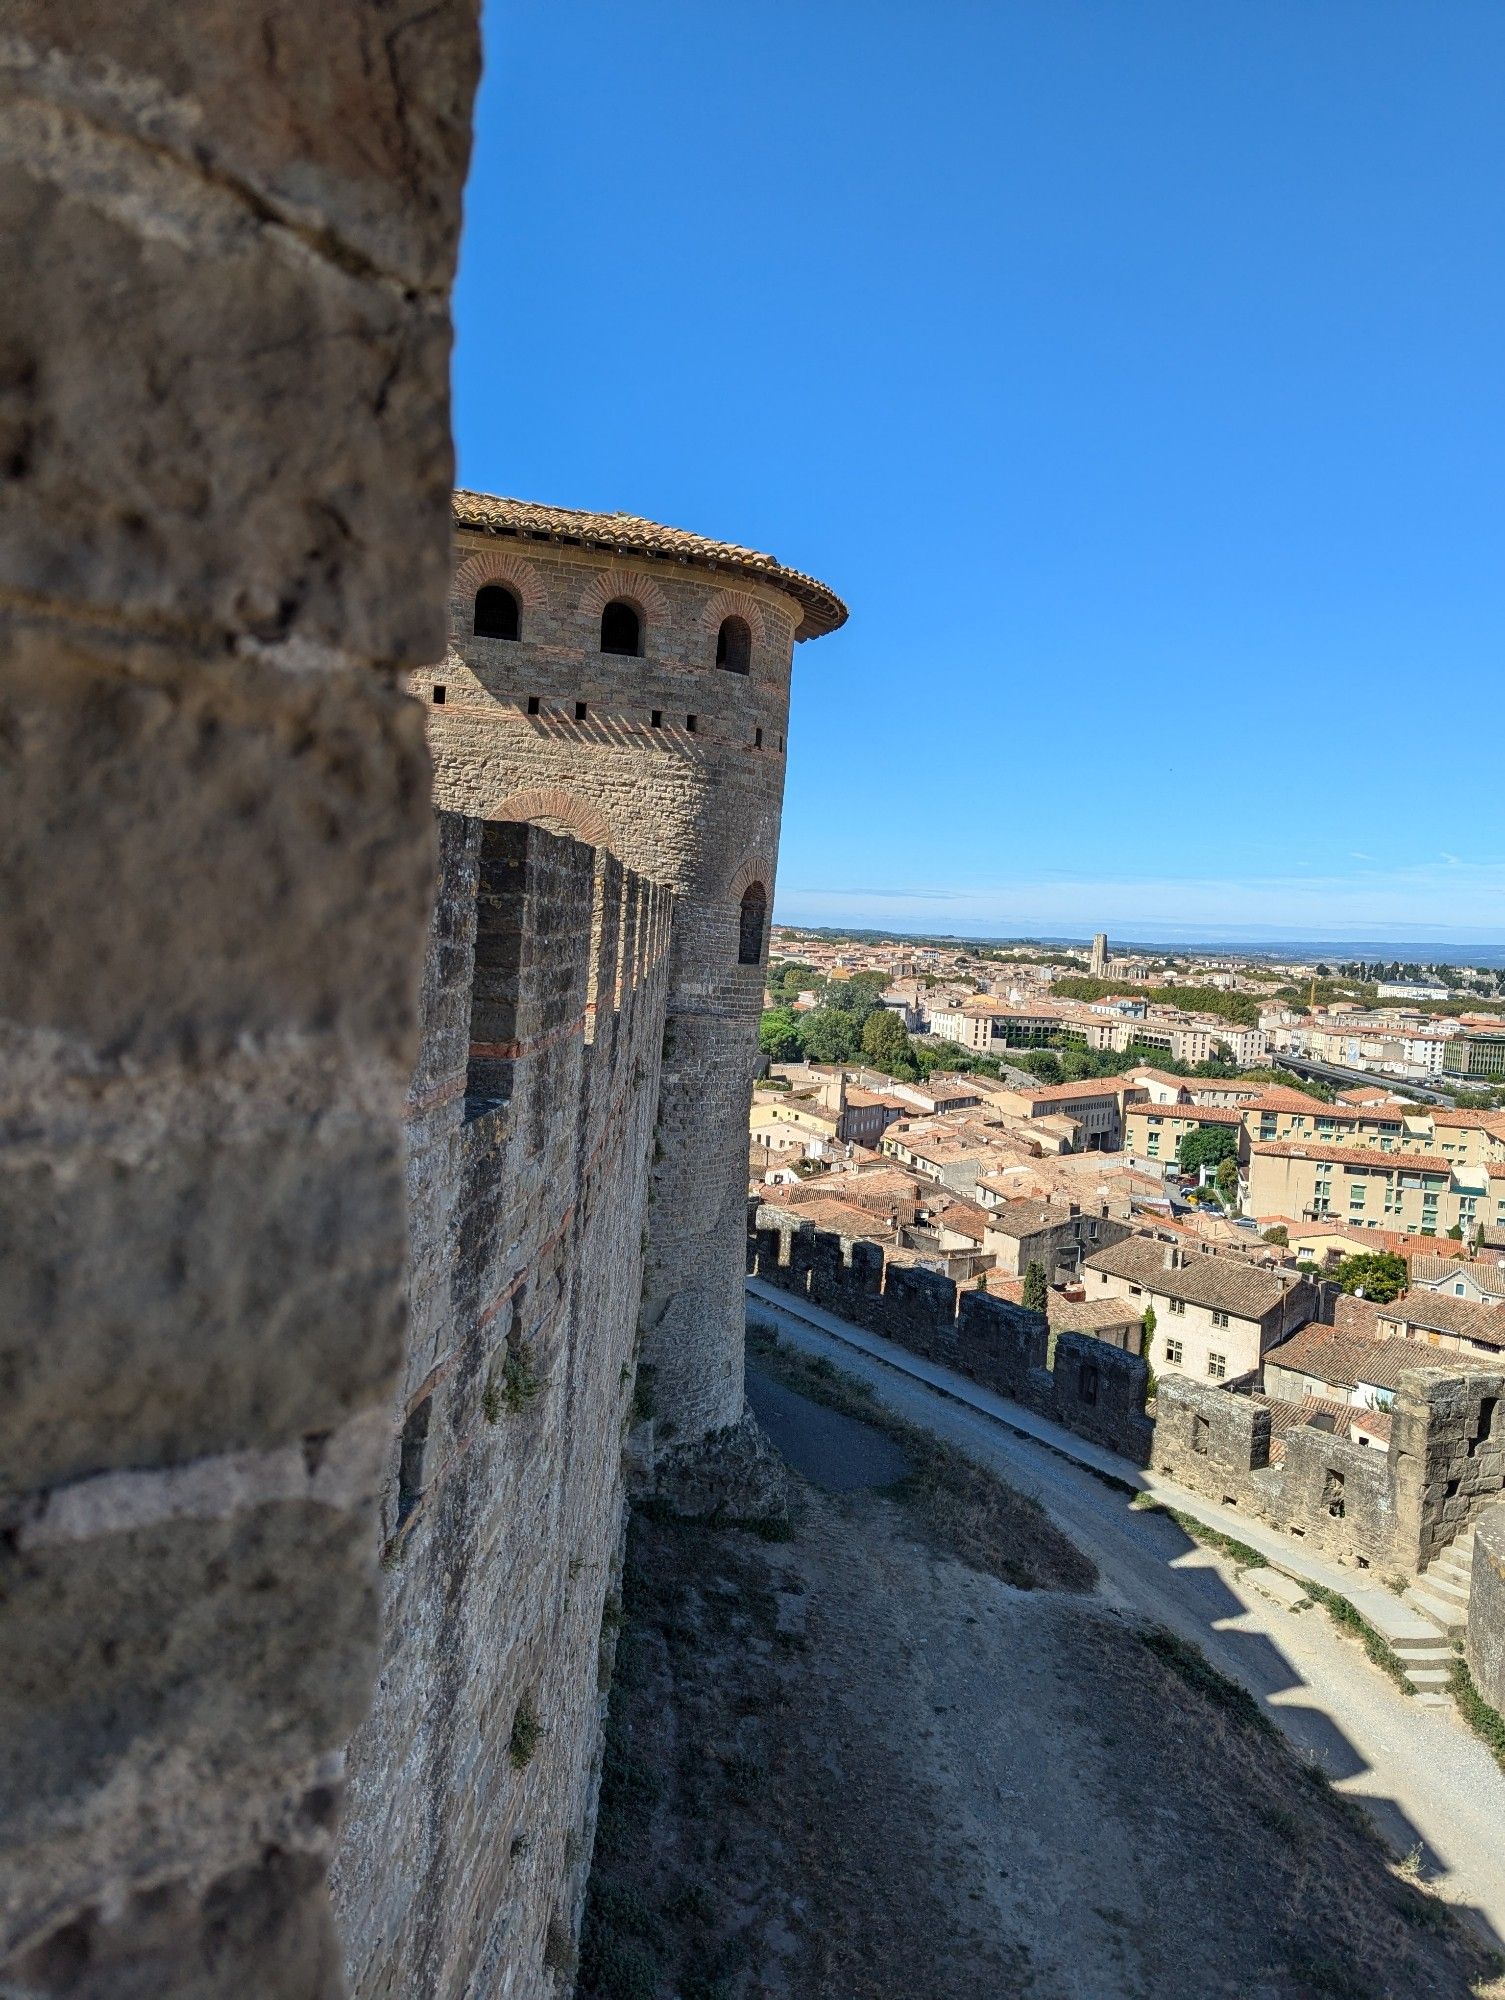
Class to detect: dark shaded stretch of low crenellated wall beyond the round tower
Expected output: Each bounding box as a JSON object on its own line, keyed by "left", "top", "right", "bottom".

{"left": 746, "top": 1202, "right": 1153, "bottom": 1466}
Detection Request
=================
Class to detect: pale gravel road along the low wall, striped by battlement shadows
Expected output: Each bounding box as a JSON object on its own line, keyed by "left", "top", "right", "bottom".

{"left": 748, "top": 1286, "right": 1505, "bottom": 1946}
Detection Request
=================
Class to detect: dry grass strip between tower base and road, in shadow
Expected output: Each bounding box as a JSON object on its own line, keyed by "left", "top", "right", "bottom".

{"left": 746, "top": 1322, "right": 1097, "bottom": 1590}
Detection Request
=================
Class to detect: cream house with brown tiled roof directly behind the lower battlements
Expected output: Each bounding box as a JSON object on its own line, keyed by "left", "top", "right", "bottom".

{"left": 1083, "top": 1236, "right": 1319, "bottom": 1382}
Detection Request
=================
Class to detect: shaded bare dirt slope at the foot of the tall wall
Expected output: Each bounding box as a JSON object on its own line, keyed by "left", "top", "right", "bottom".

{"left": 578, "top": 1336, "right": 1487, "bottom": 2000}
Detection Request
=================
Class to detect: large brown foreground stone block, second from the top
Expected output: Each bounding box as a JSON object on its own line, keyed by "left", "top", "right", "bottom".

{"left": 0, "top": 159, "right": 452, "bottom": 664}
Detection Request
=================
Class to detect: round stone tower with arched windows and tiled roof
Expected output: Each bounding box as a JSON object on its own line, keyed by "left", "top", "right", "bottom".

{"left": 412, "top": 492, "right": 847, "bottom": 1450}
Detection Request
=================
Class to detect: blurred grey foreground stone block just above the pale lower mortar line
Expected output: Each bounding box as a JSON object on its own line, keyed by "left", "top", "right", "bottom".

{"left": 0, "top": 1098, "right": 404, "bottom": 1490}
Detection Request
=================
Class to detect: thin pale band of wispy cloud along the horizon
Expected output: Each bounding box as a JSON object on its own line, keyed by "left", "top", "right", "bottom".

{"left": 777, "top": 854, "right": 1505, "bottom": 942}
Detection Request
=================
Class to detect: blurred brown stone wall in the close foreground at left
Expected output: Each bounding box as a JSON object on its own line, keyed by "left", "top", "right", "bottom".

{"left": 0, "top": 0, "right": 478, "bottom": 2000}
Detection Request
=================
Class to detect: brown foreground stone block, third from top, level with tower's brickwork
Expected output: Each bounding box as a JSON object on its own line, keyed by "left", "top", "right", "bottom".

{"left": 0, "top": 624, "right": 432, "bottom": 1064}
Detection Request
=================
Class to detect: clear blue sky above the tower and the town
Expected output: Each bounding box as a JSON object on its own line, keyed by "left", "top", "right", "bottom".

{"left": 454, "top": 0, "right": 1505, "bottom": 942}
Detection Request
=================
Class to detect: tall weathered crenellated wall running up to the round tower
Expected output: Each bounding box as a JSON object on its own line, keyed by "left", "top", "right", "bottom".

{"left": 336, "top": 814, "right": 670, "bottom": 2000}
